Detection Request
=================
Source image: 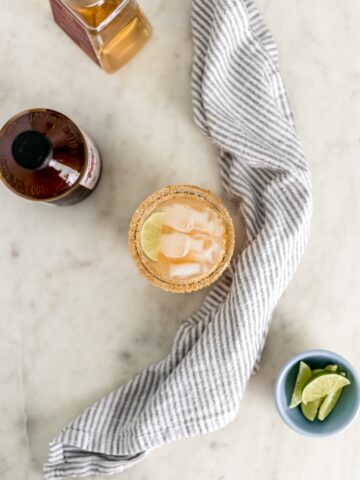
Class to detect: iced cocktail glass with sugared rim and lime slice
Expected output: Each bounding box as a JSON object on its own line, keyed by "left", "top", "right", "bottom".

{"left": 129, "top": 185, "right": 235, "bottom": 293}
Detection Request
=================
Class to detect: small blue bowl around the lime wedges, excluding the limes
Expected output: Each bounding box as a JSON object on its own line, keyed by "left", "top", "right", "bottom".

{"left": 274, "top": 350, "right": 360, "bottom": 437}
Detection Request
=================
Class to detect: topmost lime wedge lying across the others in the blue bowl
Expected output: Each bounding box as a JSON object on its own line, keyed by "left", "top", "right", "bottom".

{"left": 301, "top": 371, "right": 350, "bottom": 405}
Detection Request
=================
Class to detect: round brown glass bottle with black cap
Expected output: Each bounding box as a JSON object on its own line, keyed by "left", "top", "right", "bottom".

{"left": 0, "top": 109, "right": 101, "bottom": 205}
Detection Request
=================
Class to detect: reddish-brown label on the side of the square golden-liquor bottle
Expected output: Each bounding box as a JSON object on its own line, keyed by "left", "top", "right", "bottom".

{"left": 50, "top": 0, "right": 100, "bottom": 65}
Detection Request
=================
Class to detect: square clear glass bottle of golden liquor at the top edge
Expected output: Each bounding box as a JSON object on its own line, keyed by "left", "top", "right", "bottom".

{"left": 50, "top": 0, "right": 151, "bottom": 73}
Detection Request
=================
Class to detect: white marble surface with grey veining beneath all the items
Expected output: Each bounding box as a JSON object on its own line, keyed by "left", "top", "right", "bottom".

{"left": 0, "top": 0, "right": 360, "bottom": 480}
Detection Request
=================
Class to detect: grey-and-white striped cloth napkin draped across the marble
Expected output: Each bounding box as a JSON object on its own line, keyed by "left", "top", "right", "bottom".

{"left": 45, "top": 0, "right": 312, "bottom": 479}
